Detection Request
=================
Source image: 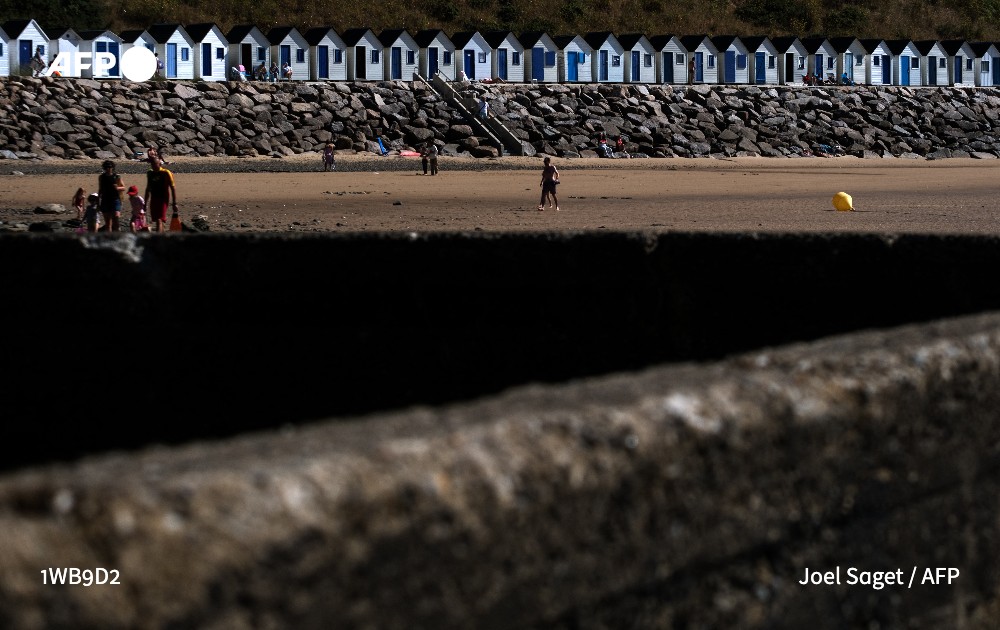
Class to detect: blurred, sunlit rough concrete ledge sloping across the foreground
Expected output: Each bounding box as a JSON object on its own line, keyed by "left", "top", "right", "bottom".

{"left": 0, "top": 313, "right": 1000, "bottom": 630}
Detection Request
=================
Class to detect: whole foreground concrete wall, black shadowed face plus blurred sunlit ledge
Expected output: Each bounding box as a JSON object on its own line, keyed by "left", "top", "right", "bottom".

{"left": 0, "top": 234, "right": 1000, "bottom": 630}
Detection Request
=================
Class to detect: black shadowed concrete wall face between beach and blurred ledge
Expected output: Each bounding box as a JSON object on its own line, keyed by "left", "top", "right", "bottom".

{"left": 0, "top": 233, "right": 1000, "bottom": 468}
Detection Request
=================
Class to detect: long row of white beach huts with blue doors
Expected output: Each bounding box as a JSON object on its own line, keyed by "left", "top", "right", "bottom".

{"left": 0, "top": 19, "right": 1000, "bottom": 86}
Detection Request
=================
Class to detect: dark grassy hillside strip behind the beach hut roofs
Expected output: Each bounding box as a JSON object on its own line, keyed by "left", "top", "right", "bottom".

{"left": 0, "top": 0, "right": 1000, "bottom": 40}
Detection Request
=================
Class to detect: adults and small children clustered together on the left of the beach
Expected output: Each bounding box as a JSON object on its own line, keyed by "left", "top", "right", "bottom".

{"left": 71, "top": 147, "right": 179, "bottom": 233}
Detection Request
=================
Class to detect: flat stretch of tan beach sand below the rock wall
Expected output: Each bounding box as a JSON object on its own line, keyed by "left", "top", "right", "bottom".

{"left": 0, "top": 155, "right": 1000, "bottom": 234}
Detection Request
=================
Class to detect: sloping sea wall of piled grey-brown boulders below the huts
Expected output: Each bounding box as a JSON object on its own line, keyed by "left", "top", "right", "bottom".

{"left": 0, "top": 77, "right": 1000, "bottom": 159}
